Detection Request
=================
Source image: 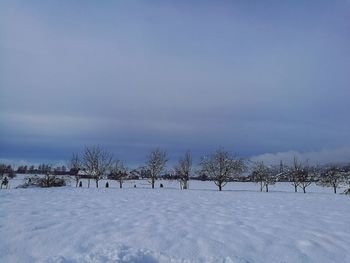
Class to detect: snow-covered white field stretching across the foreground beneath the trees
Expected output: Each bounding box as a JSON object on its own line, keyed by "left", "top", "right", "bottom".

{"left": 0, "top": 181, "right": 350, "bottom": 263}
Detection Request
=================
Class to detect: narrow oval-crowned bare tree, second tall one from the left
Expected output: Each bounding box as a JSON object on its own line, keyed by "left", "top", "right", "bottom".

{"left": 146, "top": 148, "right": 168, "bottom": 189}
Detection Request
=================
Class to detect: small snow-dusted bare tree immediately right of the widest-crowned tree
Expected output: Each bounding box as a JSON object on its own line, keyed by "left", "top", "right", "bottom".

{"left": 252, "top": 162, "right": 277, "bottom": 192}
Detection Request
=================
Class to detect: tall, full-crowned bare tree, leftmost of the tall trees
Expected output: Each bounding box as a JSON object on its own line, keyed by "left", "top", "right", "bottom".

{"left": 83, "top": 146, "right": 112, "bottom": 188}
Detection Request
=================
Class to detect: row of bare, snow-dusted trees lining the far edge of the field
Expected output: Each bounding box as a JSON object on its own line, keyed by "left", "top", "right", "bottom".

{"left": 65, "top": 146, "right": 350, "bottom": 193}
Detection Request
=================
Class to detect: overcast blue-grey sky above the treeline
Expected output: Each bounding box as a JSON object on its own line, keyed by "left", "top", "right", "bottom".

{"left": 0, "top": 0, "right": 350, "bottom": 167}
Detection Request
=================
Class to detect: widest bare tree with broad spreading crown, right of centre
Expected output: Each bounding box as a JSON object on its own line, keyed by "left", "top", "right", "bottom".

{"left": 200, "top": 150, "right": 245, "bottom": 191}
